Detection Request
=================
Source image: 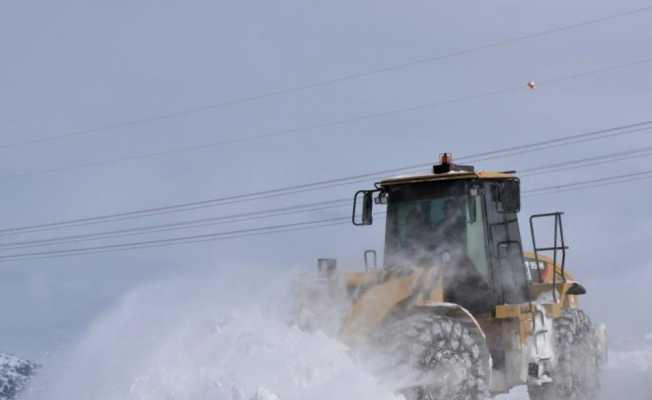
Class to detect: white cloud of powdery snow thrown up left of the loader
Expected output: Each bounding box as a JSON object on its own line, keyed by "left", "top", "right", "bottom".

{"left": 24, "top": 268, "right": 396, "bottom": 400}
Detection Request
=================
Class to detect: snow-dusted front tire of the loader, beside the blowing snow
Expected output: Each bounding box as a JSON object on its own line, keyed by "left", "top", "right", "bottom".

{"left": 375, "top": 312, "right": 491, "bottom": 400}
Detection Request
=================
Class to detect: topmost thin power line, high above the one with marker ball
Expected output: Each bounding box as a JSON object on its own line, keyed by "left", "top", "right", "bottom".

{"left": 0, "top": 6, "right": 652, "bottom": 149}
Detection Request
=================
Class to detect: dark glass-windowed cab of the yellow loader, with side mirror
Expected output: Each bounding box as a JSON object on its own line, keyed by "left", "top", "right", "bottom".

{"left": 354, "top": 156, "right": 529, "bottom": 313}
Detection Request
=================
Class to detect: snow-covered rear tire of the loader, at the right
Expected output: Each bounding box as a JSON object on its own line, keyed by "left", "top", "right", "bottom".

{"left": 528, "top": 309, "right": 600, "bottom": 400}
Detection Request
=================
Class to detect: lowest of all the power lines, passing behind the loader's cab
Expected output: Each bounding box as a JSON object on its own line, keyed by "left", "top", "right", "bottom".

{"left": 0, "top": 170, "right": 652, "bottom": 263}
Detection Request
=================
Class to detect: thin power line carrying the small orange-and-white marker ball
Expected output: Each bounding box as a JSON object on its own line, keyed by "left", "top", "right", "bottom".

{"left": 5, "top": 57, "right": 652, "bottom": 179}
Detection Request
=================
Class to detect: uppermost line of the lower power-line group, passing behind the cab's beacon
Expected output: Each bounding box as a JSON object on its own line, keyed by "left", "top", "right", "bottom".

{"left": 0, "top": 121, "right": 652, "bottom": 235}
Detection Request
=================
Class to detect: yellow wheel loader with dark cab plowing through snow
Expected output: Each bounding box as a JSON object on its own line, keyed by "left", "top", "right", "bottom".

{"left": 297, "top": 154, "right": 606, "bottom": 400}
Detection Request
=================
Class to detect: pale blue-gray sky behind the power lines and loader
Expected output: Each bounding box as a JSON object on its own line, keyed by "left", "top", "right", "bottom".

{"left": 0, "top": 0, "right": 652, "bottom": 358}
